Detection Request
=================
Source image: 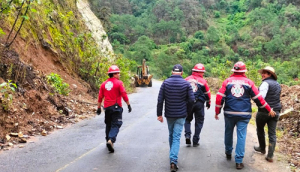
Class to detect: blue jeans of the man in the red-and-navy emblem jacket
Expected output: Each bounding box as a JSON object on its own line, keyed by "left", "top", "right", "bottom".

{"left": 224, "top": 117, "right": 250, "bottom": 163}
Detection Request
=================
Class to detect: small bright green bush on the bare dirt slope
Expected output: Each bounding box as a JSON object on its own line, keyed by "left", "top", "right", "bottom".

{"left": 47, "top": 73, "right": 70, "bottom": 96}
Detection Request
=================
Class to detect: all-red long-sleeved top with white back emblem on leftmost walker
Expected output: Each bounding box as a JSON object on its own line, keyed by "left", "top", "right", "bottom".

{"left": 98, "top": 78, "right": 128, "bottom": 108}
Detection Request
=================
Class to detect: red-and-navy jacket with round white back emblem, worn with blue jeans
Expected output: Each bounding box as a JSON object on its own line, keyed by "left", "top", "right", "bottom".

{"left": 215, "top": 73, "right": 271, "bottom": 118}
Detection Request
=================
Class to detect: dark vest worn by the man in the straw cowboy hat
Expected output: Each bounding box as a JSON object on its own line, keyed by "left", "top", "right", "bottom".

{"left": 259, "top": 77, "right": 281, "bottom": 111}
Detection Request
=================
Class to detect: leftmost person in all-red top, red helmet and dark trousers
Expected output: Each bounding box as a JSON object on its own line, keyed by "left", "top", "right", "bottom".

{"left": 97, "top": 65, "right": 132, "bottom": 153}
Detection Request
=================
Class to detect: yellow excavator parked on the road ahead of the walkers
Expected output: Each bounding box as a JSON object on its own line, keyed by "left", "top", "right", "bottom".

{"left": 134, "top": 59, "right": 152, "bottom": 87}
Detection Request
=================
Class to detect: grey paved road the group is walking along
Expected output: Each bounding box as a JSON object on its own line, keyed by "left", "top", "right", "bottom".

{"left": 0, "top": 81, "right": 288, "bottom": 172}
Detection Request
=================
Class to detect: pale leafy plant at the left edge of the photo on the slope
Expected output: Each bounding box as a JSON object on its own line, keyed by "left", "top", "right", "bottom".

{"left": 0, "top": 80, "right": 17, "bottom": 111}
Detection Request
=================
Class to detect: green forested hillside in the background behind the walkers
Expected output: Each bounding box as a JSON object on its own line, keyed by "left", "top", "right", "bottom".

{"left": 89, "top": 0, "right": 300, "bottom": 85}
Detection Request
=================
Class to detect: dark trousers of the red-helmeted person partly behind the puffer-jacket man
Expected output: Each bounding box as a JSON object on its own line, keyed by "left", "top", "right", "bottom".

{"left": 184, "top": 101, "right": 205, "bottom": 143}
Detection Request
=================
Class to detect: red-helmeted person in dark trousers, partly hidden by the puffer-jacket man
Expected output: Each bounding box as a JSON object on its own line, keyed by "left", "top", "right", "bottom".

{"left": 184, "top": 63, "right": 211, "bottom": 147}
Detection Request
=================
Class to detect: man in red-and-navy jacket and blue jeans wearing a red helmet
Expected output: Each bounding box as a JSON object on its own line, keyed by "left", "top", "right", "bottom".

{"left": 215, "top": 62, "right": 275, "bottom": 169}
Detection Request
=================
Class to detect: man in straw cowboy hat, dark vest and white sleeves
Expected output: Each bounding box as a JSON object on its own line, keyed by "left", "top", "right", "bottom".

{"left": 254, "top": 66, "right": 281, "bottom": 162}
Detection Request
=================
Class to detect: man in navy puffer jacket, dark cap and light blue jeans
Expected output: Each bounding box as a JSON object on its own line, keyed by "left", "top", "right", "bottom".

{"left": 157, "top": 64, "right": 195, "bottom": 172}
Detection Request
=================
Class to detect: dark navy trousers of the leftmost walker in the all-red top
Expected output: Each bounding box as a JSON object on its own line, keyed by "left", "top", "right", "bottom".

{"left": 104, "top": 107, "right": 123, "bottom": 143}
